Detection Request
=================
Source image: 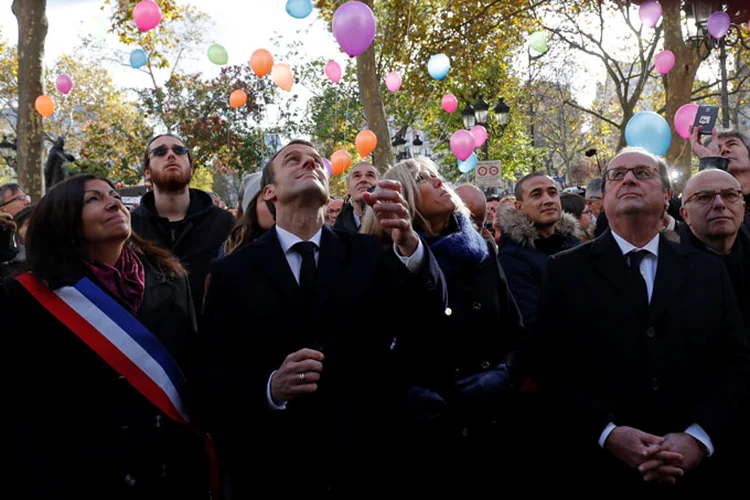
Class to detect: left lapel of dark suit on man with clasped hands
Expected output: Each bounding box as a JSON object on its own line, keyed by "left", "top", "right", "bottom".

{"left": 591, "top": 229, "right": 661, "bottom": 315}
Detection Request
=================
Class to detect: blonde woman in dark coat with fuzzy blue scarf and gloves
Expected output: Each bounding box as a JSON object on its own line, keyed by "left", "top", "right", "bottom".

{"left": 362, "top": 157, "right": 524, "bottom": 498}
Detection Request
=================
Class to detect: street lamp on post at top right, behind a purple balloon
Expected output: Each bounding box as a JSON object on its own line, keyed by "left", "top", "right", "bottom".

{"left": 684, "top": 0, "right": 750, "bottom": 128}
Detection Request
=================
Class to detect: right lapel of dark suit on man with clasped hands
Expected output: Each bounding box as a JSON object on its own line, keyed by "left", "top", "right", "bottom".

{"left": 648, "top": 236, "right": 689, "bottom": 325}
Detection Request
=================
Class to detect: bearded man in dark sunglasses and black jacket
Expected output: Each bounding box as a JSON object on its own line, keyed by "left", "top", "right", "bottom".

{"left": 131, "top": 134, "right": 234, "bottom": 314}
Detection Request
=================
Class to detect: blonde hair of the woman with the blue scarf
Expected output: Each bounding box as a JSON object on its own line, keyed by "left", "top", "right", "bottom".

{"left": 360, "top": 156, "right": 471, "bottom": 242}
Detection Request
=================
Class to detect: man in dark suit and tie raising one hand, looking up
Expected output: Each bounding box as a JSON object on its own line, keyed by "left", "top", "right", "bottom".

{"left": 201, "top": 141, "right": 446, "bottom": 499}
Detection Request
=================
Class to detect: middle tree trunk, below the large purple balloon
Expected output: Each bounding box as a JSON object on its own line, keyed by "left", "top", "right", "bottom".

{"left": 357, "top": 0, "right": 393, "bottom": 172}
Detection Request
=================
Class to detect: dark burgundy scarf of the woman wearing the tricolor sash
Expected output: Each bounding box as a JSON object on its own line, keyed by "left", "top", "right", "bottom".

{"left": 85, "top": 247, "right": 146, "bottom": 313}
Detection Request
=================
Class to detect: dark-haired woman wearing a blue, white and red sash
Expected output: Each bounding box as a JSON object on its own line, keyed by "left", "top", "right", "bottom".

{"left": 0, "top": 175, "right": 216, "bottom": 500}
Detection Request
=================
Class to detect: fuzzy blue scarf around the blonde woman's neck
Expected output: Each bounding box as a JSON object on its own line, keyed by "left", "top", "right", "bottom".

{"left": 417, "top": 212, "right": 490, "bottom": 278}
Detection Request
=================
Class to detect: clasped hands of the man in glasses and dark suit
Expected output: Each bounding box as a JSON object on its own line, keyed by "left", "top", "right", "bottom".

{"left": 604, "top": 426, "right": 705, "bottom": 484}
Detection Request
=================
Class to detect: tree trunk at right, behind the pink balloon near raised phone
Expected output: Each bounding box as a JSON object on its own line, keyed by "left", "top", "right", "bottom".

{"left": 661, "top": 0, "right": 701, "bottom": 192}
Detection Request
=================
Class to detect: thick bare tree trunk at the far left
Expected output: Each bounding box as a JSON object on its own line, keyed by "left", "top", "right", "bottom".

{"left": 11, "top": 0, "right": 47, "bottom": 201}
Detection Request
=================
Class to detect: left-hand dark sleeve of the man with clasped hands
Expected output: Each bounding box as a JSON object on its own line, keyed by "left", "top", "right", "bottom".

{"left": 531, "top": 256, "right": 615, "bottom": 445}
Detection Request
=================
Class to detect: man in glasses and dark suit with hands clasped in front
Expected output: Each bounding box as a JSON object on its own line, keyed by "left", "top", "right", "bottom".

{"left": 536, "top": 148, "right": 750, "bottom": 494}
